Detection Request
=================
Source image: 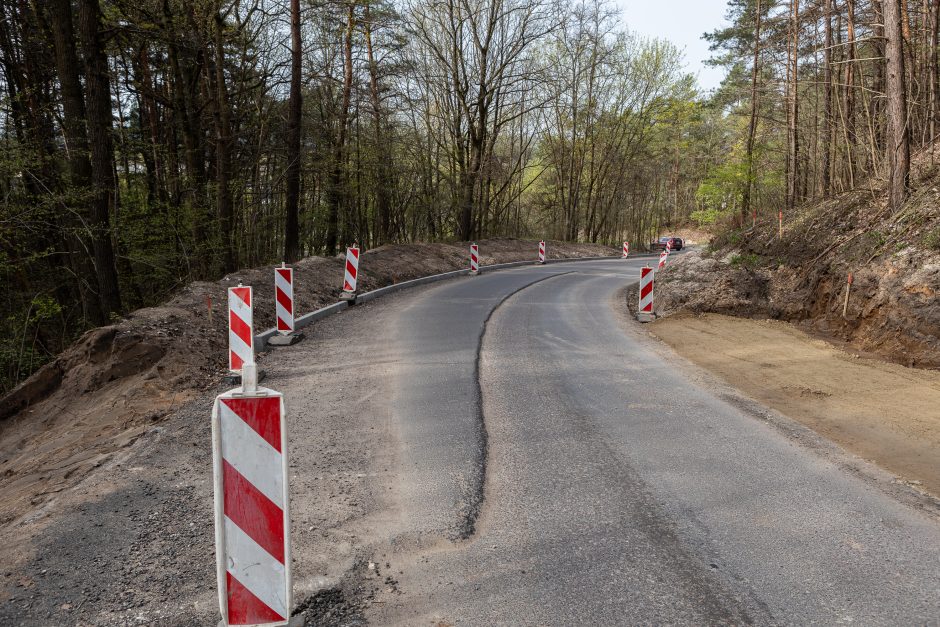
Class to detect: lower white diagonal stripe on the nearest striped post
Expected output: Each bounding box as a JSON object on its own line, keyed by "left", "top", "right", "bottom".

{"left": 225, "top": 516, "right": 287, "bottom": 618}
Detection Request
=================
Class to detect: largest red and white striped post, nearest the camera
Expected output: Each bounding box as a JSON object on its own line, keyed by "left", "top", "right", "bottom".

{"left": 212, "top": 362, "right": 298, "bottom": 625}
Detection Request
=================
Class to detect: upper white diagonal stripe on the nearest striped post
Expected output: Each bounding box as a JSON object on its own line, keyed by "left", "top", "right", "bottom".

{"left": 219, "top": 402, "right": 284, "bottom": 509}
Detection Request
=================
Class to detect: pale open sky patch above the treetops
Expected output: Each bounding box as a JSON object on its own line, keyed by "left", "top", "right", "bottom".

{"left": 615, "top": 0, "right": 727, "bottom": 91}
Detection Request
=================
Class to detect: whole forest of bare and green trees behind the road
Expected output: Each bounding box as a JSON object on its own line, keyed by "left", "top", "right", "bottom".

{"left": 0, "top": 0, "right": 924, "bottom": 393}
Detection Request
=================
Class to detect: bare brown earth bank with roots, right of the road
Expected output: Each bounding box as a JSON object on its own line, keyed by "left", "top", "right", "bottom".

{"left": 631, "top": 147, "right": 940, "bottom": 368}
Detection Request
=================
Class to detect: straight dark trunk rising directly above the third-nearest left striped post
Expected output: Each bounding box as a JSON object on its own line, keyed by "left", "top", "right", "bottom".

{"left": 284, "top": 0, "right": 303, "bottom": 263}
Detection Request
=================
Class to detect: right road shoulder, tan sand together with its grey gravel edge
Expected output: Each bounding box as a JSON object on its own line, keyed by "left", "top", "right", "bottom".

{"left": 611, "top": 288, "right": 940, "bottom": 521}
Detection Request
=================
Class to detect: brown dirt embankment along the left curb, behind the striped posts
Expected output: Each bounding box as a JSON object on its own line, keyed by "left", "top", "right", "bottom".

{"left": 0, "top": 239, "right": 620, "bottom": 527}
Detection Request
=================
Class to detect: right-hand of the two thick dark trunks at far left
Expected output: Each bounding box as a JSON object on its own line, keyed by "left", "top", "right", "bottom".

{"left": 79, "top": 0, "right": 122, "bottom": 319}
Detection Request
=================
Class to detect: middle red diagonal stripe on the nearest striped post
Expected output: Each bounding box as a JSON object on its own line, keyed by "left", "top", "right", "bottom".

{"left": 222, "top": 459, "right": 284, "bottom": 564}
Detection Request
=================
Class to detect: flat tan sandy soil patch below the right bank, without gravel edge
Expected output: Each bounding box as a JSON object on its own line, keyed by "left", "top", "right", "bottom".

{"left": 646, "top": 314, "right": 940, "bottom": 496}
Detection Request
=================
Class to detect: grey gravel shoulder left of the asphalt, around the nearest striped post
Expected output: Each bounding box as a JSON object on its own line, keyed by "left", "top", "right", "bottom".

{"left": 0, "top": 295, "right": 412, "bottom": 626}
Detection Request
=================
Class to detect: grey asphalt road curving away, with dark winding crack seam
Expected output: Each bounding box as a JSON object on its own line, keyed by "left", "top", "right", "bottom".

{"left": 363, "top": 260, "right": 940, "bottom": 625}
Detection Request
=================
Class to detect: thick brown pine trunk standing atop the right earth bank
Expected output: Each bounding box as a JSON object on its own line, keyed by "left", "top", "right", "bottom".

{"left": 883, "top": 0, "right": 911, "bottom": 211}
